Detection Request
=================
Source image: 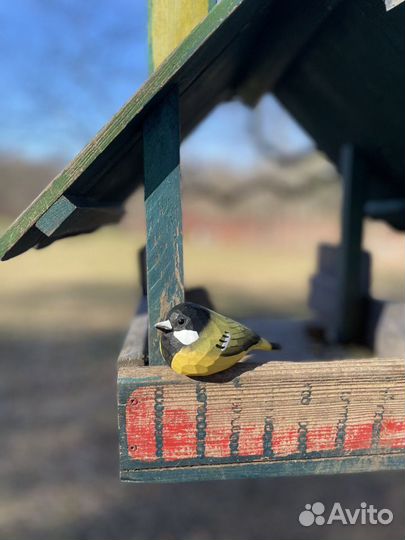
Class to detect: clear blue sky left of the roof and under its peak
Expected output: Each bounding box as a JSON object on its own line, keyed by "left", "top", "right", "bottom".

{"left": 0, "top": 0, "right": 311, "bottom": 168}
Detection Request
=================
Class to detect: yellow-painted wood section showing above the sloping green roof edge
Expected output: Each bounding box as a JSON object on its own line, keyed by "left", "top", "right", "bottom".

{"left": 148, "top": 0, "right": 210, "bottom": 72}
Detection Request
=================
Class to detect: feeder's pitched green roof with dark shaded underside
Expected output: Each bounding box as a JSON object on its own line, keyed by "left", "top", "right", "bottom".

{"left": 0, "top": 0, "right": 405, "bottom": 259}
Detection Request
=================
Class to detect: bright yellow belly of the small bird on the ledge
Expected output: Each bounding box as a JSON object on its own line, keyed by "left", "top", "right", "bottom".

{"left": 171, "top": 351, "right": 246, "bottom": 377}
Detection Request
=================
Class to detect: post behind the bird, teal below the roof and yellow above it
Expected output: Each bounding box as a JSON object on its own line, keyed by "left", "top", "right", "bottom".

{"left": 143, "top": 0, "right": 214, "bottom": 365}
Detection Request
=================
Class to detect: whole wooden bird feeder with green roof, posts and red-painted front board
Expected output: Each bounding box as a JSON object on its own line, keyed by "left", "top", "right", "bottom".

{"left": 0, "top": 0, "right": 405, "bottom": 482}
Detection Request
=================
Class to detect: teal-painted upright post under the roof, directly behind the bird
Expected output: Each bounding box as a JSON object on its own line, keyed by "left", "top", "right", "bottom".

{"left": 143, "top": 88, "right": 184, "bottom": 365}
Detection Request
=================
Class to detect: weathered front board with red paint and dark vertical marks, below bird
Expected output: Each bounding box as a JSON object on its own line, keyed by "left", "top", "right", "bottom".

{"left": 118, "top": 358, "right": 405, "bottom": 481}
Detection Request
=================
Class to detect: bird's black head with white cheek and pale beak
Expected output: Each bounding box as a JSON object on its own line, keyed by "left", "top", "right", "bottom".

{"left": 155, "top": 302, "right": 210, "bottom": 364}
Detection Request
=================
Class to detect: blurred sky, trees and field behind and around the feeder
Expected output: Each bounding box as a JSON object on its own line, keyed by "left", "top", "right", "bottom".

{"left": 0, "top": 0, "right": 404, "bottom": 540}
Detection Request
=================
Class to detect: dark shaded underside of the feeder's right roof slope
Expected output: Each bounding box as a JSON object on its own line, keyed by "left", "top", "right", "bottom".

{"left": 274, "top": 0, "right": 405, "bottom": 230}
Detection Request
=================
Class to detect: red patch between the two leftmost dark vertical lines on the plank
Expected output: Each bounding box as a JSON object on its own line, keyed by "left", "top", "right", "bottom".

{"left": 163, "top": 406, "right": 197, "bottom": 461}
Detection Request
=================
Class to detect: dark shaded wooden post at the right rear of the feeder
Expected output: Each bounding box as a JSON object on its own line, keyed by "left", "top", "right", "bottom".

{"left": 336, "top": 145, "right": 366, "bottom": 343}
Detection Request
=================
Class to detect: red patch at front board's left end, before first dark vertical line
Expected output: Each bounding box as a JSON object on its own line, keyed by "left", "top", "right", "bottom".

{"left": 126, "top": 387, "right": 156, "bottom": 461}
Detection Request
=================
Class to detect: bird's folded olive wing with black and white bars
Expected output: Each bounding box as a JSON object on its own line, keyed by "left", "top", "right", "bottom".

{"left": 213, "top": 314, "right": 260, "bottom": 356}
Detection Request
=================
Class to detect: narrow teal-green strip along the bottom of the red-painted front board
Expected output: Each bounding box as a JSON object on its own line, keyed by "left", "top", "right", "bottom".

{"left": 121, "top": 453, "right": 405, "bottom": 482}
